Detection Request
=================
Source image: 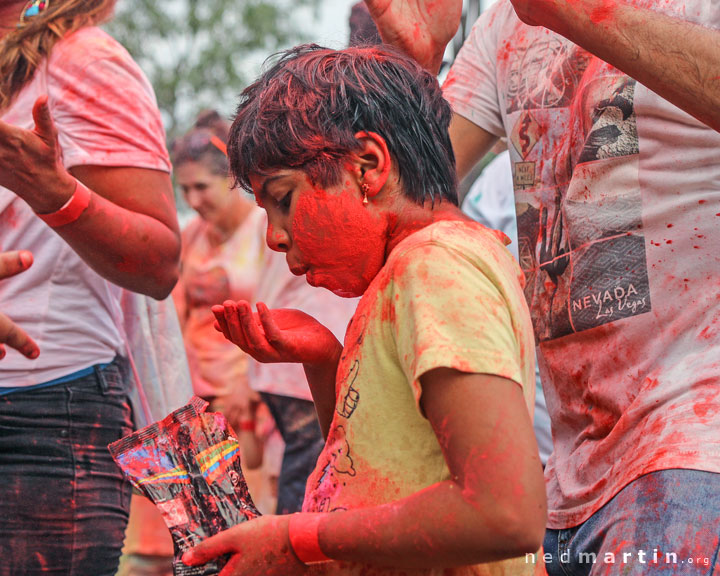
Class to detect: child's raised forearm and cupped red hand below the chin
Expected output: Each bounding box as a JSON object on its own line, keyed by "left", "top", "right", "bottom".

{"left": 212, "top": 300, "right": 343, "bottom": 438}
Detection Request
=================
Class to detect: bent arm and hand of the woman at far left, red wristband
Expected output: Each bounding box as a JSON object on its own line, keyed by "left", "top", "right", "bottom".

{"left": 0, "top": 97, "right": 180, "bottom": 299}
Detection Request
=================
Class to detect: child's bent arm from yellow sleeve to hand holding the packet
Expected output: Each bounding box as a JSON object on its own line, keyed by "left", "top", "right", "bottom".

{"left": 183, "top": 368, "right": 546, "bottom": 576}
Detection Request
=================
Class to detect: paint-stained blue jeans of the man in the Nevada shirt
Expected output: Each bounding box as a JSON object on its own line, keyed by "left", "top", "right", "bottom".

{"left": 543, "top": 469, "right": 720, "bottom": 576}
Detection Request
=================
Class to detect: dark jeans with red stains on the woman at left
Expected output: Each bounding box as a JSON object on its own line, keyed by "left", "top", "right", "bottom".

{"left": 0, "top": 359, "right": 132, "bottom": 576}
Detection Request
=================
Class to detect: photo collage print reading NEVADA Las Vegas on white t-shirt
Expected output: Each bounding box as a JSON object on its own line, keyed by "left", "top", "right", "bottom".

{"left": 506, "top": 38, "right": 651, "bottom": 342}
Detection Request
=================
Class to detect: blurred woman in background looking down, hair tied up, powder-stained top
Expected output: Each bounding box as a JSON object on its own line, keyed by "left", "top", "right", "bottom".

{"left": 172, "top": 111, "right": 266, "bottom": 433}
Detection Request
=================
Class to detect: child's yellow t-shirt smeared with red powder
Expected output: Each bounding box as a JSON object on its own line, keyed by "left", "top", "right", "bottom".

{"left": 303, "top": 221, "right": 535, "bottom": 575}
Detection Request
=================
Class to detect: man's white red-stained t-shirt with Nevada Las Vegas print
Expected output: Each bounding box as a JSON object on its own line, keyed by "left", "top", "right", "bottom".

{"left": 444, "top": 0, "right": 720, "bottom": 528}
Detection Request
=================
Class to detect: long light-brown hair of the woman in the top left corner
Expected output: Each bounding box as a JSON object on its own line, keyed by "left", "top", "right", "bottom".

{"left": 0, "top": 0, "right": 115, "bottom": 110}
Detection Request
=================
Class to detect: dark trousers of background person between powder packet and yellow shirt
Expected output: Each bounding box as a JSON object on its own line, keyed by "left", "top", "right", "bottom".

{"left": 260, "top": 392, "right": 325, "bottom": 514}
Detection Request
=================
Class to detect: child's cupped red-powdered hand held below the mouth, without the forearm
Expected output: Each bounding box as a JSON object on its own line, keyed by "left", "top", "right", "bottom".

{"left": 212, "top": 300, "right": 342, "bottom": 366}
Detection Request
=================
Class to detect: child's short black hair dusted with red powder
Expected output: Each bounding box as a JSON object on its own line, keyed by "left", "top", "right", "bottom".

{"left": 228, "top": 44, "right": 457, "bottom": 205}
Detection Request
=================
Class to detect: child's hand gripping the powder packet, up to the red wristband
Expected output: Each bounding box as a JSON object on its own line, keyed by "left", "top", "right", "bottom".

{"left": 182, "top": 515, "right": 307, "bottom": 576}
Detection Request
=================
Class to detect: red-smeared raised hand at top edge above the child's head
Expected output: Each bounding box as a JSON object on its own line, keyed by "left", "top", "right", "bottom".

{"left": 365, "top": 0, "right": 462, "bottom": 74}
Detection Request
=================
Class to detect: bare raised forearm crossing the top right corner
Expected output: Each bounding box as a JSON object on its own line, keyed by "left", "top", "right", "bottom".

{"left": 510, "top": 0, "right": 720, "bottom": 130}
